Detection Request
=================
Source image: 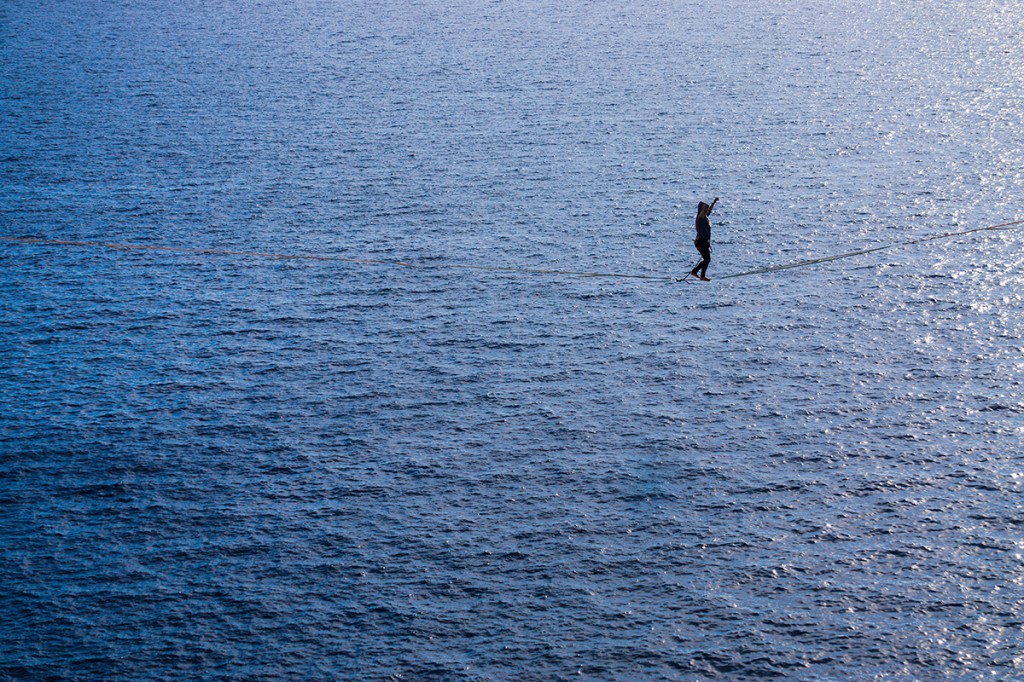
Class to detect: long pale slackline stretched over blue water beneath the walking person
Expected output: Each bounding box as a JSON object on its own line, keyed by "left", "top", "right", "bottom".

{"left": 0, "top": 220, "right": 1024, "bottom": 282}
